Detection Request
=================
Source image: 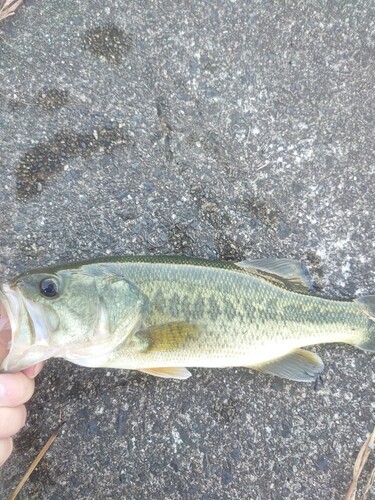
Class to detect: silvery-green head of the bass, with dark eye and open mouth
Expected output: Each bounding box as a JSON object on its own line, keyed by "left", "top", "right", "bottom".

{"left": 0, "top": 265, "right": 142, "bottom": 372}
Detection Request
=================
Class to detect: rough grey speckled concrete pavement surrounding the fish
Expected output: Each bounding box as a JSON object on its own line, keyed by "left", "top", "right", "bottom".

{"left": 0, "top": 0, "right": 375, "bottom": 500}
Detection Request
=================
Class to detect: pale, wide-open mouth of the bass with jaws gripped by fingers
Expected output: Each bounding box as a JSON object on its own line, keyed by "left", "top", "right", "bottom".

{"left": 0, "top": 284, "right": 59, "bottom": 372}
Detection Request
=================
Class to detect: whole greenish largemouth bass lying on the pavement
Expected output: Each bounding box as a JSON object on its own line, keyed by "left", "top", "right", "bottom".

{"left": 0, "top": 256, "right": 375, "bottom": 382}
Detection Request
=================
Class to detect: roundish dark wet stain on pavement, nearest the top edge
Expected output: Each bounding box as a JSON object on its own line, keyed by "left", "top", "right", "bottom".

{"left": 83, "top": 24, "right": 132, "bottom": 64}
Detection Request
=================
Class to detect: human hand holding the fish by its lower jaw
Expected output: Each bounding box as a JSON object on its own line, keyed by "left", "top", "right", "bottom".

{"left": 0, "top": 334, "right": 43, "bottom": 466}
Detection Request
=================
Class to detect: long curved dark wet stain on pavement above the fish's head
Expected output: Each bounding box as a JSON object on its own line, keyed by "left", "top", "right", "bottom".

{"left": 16, "top": 122, "right": 127, "bottom": 199}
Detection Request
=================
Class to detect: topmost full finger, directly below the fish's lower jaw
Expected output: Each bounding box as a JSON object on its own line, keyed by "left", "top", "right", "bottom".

{"left": 0, "top": 373, "right": 35, "bottom": 407}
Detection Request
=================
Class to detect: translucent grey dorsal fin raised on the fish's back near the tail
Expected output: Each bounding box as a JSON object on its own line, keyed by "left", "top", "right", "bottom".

{"left": 236, "top": 259, "right": 313, "bottom": 292}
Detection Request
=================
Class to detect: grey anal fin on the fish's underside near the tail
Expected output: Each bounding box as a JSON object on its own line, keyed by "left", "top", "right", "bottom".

{"left": 248, "top": 349, "right": 324, "bottom": 382}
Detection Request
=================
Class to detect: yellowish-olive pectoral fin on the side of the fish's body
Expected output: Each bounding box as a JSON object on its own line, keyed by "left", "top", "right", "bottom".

{"left": 132, "top": 321, "right": 199, "bottom": 353}
